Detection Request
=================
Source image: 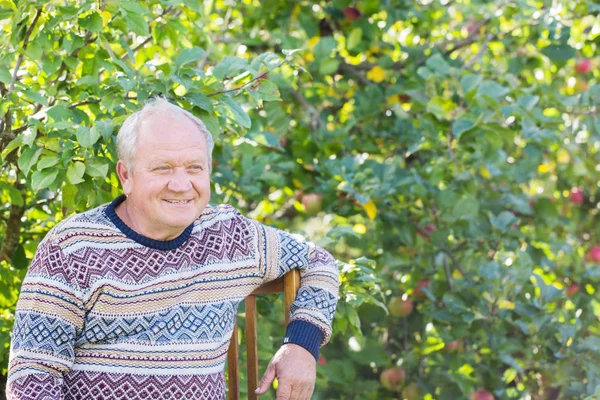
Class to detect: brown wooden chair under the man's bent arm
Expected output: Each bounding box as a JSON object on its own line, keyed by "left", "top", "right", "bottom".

{"left": 227, "top": 269, "right": 300, "bottom": 400}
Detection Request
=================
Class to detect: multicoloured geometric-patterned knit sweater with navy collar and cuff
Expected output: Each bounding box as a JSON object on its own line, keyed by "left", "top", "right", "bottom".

{"left": 7, "top": 197, "right": 339, "bottom": 400}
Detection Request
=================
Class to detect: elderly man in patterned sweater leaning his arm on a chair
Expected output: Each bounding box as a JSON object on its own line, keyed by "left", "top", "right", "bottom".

{"left": 7, "top": 98, "right": 339, "bottom": 400}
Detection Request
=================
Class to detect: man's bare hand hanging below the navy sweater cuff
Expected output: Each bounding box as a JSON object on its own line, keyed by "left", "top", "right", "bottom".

{"left": 256, "top": 343, "right": 317, "bottom": 400}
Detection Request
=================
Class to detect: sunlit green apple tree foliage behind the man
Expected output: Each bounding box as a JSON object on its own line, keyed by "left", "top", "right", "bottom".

{"left": 0, "top": 0, "right": 600, "bottom": 400}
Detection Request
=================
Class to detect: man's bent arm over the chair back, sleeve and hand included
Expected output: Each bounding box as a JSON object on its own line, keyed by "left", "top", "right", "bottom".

{"left": 248, "top": 223, "right": 339, "bottom": 399}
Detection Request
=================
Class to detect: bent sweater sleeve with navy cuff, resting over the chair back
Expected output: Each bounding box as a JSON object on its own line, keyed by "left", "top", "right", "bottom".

{"left": 251, "top": 222, "right": 339, "bottom": 359}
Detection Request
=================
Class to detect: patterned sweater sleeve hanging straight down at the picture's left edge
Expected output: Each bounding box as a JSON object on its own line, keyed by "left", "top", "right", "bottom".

{"left": 6, "top": 240, "right": 84, "bottom": 400}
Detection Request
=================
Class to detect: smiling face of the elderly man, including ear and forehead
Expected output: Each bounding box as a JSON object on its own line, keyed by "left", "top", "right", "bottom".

{"left": 117, "top": 112, "right": 210, "bottom": 240}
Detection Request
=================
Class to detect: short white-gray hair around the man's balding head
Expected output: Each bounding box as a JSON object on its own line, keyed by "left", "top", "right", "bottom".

{"left": 117, "top": 96, "right": 215, "bottom": 172}
